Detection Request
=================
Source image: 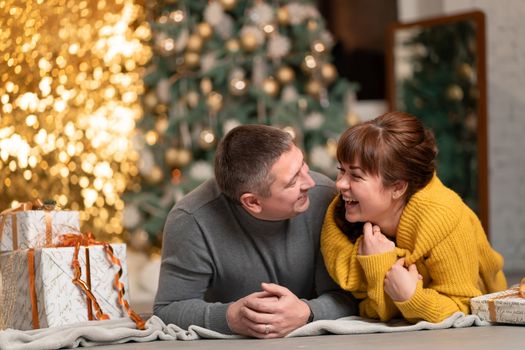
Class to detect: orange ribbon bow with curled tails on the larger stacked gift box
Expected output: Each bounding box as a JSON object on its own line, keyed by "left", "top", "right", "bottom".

{"left": 57, "top": 232, "right": 145, "bottom": 329}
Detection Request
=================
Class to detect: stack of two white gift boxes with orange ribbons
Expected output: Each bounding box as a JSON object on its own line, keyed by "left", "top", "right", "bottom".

{"left": 0, "top": 203, "right": 140, "bottom": 330}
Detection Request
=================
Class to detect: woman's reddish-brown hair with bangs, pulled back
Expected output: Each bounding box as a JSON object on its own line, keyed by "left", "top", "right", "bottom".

{"left": 336, "top": 112, "right": 438, "bottom": 239}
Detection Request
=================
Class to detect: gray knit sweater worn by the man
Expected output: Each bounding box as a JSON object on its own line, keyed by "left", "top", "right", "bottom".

{"left": 154, "top": 172, "right": 357, "bottom": 333}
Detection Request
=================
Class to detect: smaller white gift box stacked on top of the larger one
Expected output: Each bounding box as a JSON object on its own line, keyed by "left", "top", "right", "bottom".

{"left": 0, "top": 210, "right": 80, "bottom": 252}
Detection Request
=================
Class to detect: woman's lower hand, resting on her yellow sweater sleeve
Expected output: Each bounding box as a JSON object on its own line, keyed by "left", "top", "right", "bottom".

{"left": 385, "top": 258, "right": 422, "bottom": 301}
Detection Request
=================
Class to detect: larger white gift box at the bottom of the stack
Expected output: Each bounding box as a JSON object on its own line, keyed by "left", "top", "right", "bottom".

{"left": 0, "top": 244, "right": 129, "bottom": 330}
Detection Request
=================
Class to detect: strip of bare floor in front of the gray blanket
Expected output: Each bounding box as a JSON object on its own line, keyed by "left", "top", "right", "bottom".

{"left": 95, "top": 325, "right": 525, "bottom": 350}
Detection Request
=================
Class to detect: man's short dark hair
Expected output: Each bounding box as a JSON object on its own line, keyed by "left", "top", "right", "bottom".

{"left": 215, "top": 124, "right": 293, "bottom": 202}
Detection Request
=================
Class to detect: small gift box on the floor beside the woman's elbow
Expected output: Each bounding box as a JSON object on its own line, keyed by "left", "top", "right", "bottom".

{"left": 470, "top": 277, "right": 525, "bottom": 324}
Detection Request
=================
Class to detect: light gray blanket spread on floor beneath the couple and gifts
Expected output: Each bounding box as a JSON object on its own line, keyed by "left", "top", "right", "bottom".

{"left": 0, "top": 312, "right": 490, "bottom": 350}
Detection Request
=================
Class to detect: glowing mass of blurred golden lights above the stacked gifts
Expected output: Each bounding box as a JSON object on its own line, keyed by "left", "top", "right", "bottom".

{"left": 0, "top": 0, "right": 151, "bottom": 240}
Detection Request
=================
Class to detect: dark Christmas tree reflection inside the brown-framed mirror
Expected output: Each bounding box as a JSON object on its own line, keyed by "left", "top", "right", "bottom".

{"left": 395, "top": 21, "right": 480, "bottom": 214}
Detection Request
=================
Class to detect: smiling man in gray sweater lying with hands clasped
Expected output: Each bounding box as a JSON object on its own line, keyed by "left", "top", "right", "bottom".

{"left": 154, "top": 125, "right": 357, "bottom": 338}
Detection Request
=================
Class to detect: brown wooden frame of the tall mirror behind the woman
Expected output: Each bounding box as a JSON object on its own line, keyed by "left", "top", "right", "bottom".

{"left": 386, "top": 11, "right": 489, "bottom": 236}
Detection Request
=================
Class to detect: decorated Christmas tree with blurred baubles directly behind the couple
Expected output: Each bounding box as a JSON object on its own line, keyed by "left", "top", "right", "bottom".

{"left": 123, "top": 0, "right": 357, "bottom": 251}
